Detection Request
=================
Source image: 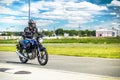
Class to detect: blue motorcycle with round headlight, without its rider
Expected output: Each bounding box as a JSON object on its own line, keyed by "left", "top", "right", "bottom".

{"left": 16, "top": 36, "right": 48, "bottom": 65}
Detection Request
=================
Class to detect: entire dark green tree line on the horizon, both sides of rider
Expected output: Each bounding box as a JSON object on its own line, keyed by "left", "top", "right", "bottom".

{"left": 1, "top": 28, "right": 96, "bottom": 37}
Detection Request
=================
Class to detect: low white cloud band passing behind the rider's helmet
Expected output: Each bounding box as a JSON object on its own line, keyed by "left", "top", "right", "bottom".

{"left": 0, "top": 16, "right": 54, "bottom": 27}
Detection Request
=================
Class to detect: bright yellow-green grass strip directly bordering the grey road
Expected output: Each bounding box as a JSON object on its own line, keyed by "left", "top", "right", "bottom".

{"left": 0, "top": 43, "right": 120, "bottom": 59}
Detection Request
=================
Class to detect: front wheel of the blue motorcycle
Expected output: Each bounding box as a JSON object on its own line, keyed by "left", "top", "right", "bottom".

{"left": 37, "top": 49, "right": 48, "bottom": 66}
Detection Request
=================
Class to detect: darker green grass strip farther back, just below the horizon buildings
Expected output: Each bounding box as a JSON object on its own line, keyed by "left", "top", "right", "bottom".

{"left": 0, "top": 37, "right": 120, "bottom": 44}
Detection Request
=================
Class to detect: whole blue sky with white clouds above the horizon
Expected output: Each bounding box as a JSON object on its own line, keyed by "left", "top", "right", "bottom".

{"left": 0, "top": 0, "right": 120, "bottom": 31}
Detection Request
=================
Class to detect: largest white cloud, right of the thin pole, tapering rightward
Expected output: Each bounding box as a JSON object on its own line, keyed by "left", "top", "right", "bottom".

{"left": 25, "top": 1, "right": 108, "bottom": 24}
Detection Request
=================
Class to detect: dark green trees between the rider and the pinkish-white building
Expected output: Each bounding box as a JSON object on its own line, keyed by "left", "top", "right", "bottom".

{"left": 43, "top": 28, "right": 96, "bottom": 37}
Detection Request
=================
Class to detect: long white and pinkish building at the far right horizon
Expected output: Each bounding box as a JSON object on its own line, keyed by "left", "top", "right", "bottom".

{"left": 96, "top": 28, "right": 120, "bottom": 37}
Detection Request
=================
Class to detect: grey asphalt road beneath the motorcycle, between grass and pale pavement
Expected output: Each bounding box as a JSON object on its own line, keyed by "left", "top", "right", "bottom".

{"left": 0, "top": 52, "right": 120, "bottom": 77}
